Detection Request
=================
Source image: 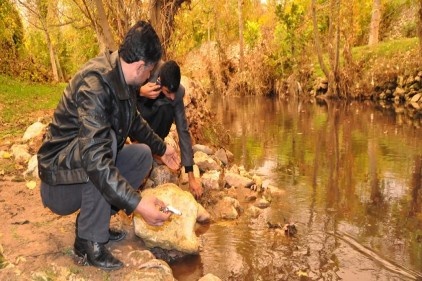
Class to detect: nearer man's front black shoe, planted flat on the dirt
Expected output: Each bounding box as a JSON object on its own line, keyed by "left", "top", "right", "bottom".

{"left": 74, "top": 236, "right": 123, "bottom": 270}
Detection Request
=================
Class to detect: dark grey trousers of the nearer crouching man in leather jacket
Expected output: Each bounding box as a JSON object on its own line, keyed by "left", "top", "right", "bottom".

{"left": 41, "top": 131, "right": 152, "bottom": 243}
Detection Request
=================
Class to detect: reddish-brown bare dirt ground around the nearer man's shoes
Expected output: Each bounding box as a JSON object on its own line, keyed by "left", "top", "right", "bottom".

{"left": 0, "top": 177, "right": 164, "bottom": 280}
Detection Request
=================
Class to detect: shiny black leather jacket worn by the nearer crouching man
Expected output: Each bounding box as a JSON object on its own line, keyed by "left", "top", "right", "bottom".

{"left": 37, "top": 51, "right": 166, "bottom": 214}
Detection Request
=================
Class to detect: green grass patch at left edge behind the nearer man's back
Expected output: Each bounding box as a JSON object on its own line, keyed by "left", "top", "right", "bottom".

{"left": 0, "top": 75, "right": 66, "bottom": 139}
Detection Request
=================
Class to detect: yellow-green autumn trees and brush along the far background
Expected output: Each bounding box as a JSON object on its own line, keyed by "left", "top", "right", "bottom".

{"left": 0, "top": 0, "right": 422, "bottom": 98}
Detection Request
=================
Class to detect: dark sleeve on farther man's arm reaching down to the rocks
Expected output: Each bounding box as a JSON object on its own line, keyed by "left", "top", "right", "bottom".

{"left": 174, "top": 85, "right": 194, "bottom": 167}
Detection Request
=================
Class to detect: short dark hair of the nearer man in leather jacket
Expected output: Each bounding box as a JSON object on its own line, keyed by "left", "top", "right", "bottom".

{"left": 119, "top": 21, "right": 162, "bottom": 64}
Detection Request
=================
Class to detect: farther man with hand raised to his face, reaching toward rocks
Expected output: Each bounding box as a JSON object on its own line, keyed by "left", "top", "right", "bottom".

{"left": 137, "top": 60, "right": 203, "bottom": 198}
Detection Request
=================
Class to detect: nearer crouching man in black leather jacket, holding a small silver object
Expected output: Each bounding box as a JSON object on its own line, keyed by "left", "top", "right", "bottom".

{"left": 38, "top": 21, "right": 180, "bottom": 270}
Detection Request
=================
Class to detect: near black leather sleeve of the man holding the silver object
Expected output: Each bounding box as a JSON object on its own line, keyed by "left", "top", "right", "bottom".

{"left": 76, "top": 75, "right": 141, "bottom": 214}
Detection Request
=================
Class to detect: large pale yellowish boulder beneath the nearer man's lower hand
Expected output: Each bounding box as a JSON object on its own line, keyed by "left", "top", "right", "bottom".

{"left": 134, "top": 183, "right": 209, "bottom": 254}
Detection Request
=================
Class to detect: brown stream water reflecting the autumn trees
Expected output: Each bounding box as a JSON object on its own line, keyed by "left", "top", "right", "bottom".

{"left": 172, "top": 97, "right": 422, "bottom": 281}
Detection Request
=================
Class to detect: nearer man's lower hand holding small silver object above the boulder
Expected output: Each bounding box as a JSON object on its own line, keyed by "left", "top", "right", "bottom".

{"left": 135, "top": 196, "right": 171, "bottom": 226}
